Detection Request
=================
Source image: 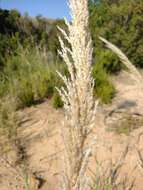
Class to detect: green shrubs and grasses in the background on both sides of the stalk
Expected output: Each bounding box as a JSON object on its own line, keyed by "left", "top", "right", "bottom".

{"left": 0, "top": 0, "right": 143, "bottom": 136}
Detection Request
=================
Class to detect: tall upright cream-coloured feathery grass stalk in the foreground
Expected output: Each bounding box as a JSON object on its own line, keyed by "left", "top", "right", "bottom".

{"left": 57, "top": 0, "right": 97, "bottom": 190}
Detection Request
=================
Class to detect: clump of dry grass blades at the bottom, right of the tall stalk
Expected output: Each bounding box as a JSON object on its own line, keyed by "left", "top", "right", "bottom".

{"left": 89, "top": 144, "right": 136, "bottom": 190}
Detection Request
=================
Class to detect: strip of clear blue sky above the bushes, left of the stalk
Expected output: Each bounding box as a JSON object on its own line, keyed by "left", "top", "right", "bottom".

{"left": 0, "top": 0, "right": 69, "bottom": 18}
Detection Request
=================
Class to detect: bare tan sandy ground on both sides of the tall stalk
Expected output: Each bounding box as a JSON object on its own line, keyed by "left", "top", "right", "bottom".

{"left": 0, "top": 73, "right": 143, "bottom": 190}
